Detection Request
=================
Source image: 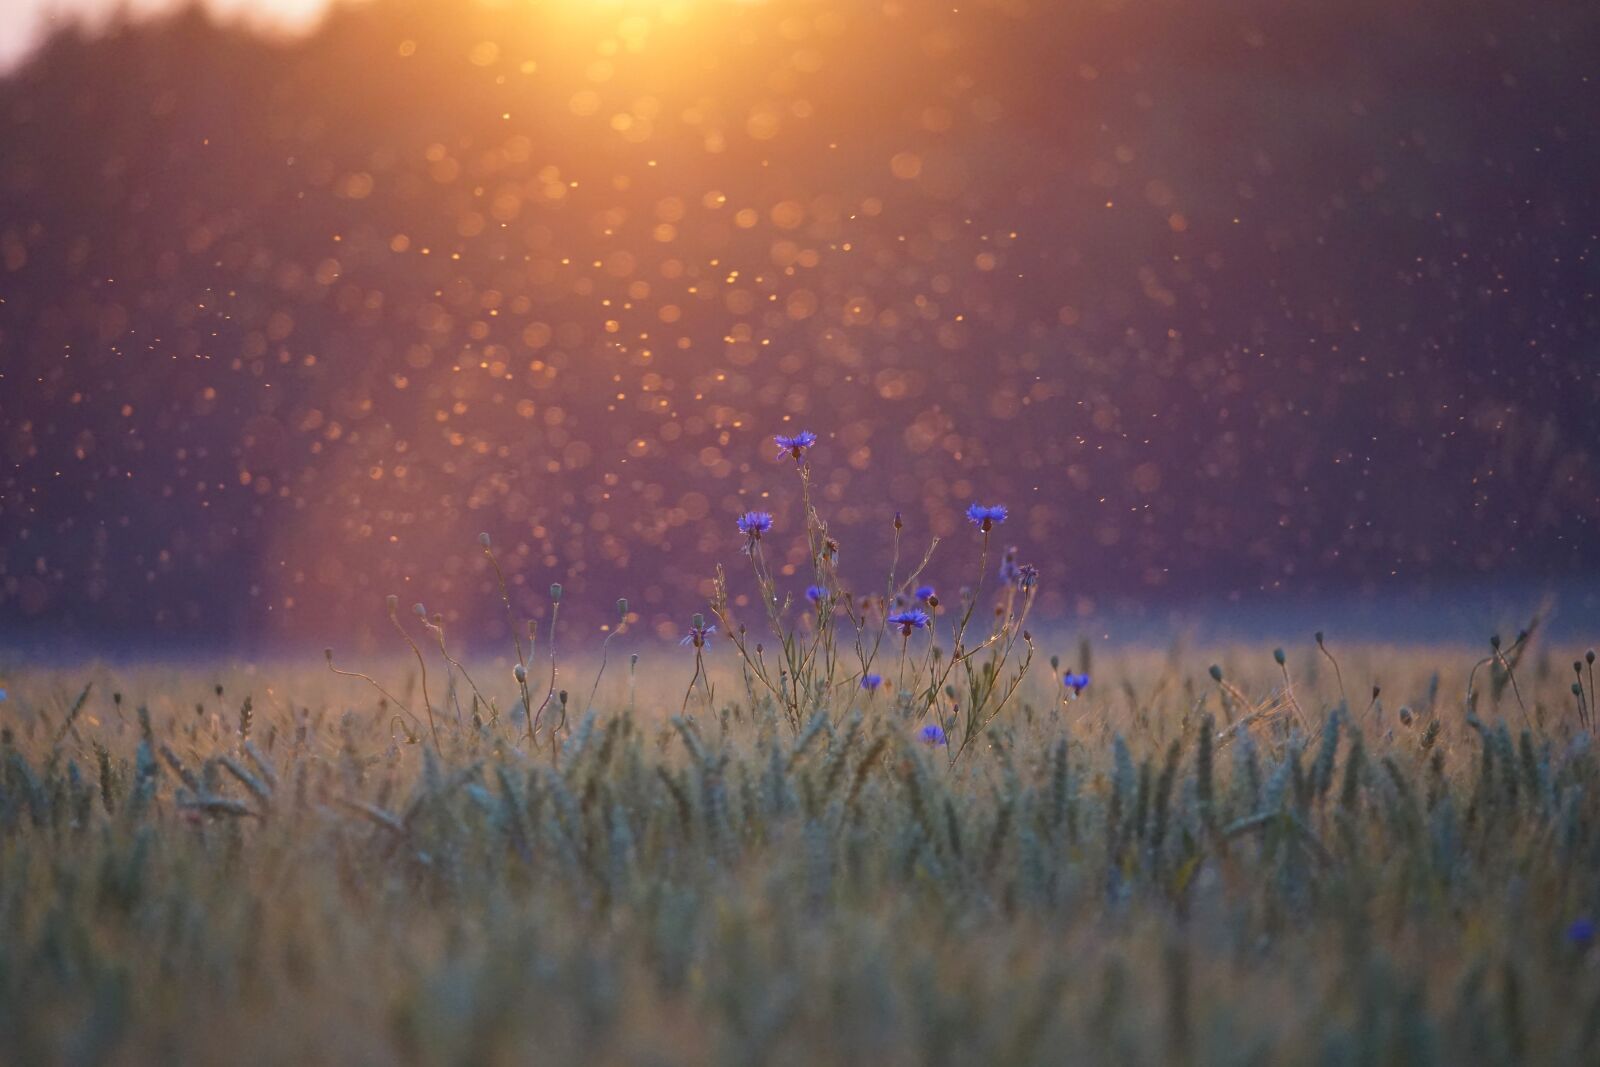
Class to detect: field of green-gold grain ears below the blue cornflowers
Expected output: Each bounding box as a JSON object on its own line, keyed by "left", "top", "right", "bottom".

{"left": 0, "top": 646, "right": 1600, "bottom": 1065}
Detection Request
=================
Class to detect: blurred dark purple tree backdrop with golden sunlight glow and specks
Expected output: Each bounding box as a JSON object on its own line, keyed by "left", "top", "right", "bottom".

{"left": 0, "top": 0, "right": 1600, "bottom": 645}
